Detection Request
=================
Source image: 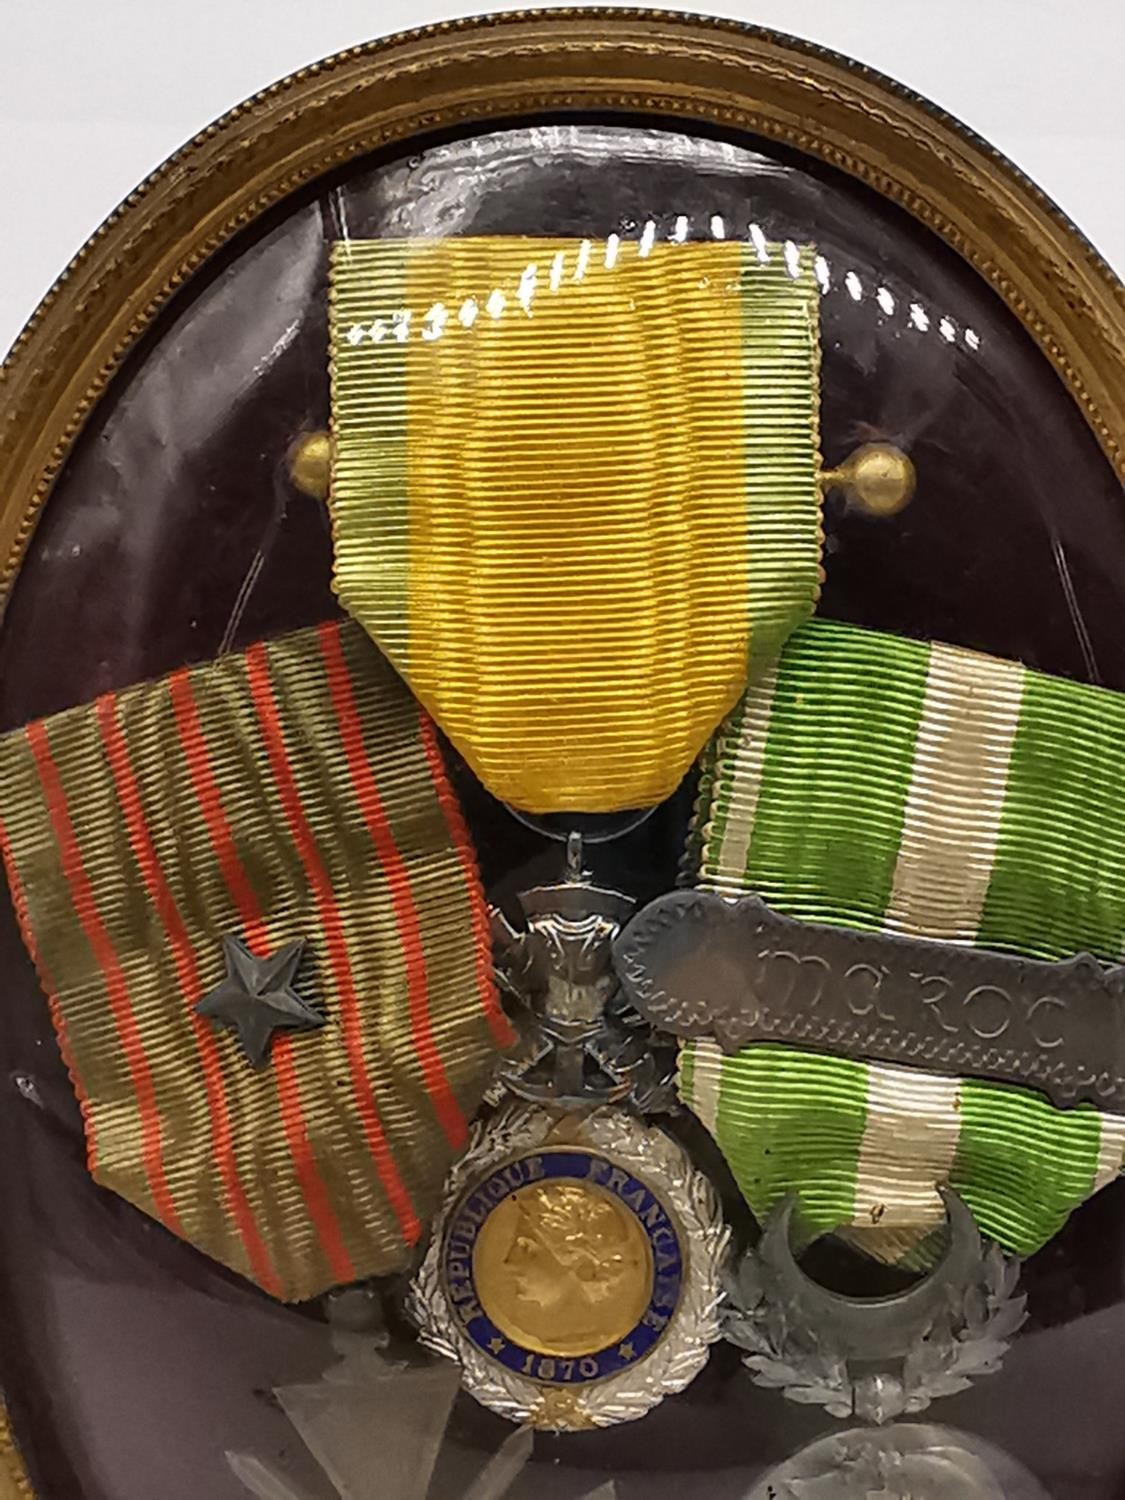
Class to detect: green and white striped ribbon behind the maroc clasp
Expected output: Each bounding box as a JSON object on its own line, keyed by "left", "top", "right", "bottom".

{"left": 680, "top": 620, "right": 1125, "bottom": 1260}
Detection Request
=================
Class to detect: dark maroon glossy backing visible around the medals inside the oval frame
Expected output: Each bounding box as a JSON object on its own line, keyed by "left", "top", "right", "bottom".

{"left": 0, "top": 122, "right": 1125, "bottom": 1500}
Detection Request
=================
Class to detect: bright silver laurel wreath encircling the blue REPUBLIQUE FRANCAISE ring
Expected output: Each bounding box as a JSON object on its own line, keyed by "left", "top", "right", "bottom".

{"left": 410, "top": 1104, "right": 729, "bottom": 1427}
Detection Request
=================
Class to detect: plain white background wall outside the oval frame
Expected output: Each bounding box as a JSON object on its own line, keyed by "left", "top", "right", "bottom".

{"left": 0, "top": 0, "right": 1125, "bottom": 360}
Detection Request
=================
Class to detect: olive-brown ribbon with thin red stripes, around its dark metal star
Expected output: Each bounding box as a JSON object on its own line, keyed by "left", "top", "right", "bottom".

{"left": 0, "top": 623, "right": 510, "bottom": 1301}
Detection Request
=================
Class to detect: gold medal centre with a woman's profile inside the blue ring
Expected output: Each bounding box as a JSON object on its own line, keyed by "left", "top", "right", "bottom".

{"left": 473, "top": 1182, "right": 653, "bottom": 1359}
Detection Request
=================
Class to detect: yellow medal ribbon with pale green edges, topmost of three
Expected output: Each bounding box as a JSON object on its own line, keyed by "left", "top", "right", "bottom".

{"left": 330, "top": 236, "right": 821, "bottom": 813}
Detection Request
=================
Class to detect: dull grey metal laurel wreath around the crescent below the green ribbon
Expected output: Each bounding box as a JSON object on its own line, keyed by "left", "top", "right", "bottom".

{"left": 723, "top": 1244, "right": 1028, "bottom": 1424}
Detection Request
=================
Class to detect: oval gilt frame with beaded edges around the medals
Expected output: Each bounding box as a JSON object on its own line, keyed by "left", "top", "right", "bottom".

{"left": 0, "top": 9, "right": 1125, "bottom": 1500}
